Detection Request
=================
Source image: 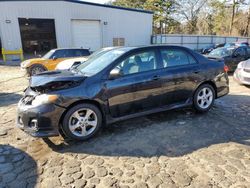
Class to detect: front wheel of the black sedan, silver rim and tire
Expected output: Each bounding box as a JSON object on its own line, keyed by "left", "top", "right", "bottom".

{"left": 62, "top": 104, "right": 102, "bottom": 140}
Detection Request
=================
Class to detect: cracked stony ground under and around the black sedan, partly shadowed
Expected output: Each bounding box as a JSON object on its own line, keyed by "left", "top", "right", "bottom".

{"left": 0, "top": 65, "right": 250, "bottom": 188}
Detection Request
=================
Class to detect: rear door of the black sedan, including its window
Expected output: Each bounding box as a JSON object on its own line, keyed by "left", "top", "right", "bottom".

{"left": 160, "top": 47, "right": 203, "bottom": 105}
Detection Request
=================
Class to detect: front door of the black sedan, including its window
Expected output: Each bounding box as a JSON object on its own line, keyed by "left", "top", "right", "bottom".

{"left": 106, "top": 50, "right": 161, "bottom": 117}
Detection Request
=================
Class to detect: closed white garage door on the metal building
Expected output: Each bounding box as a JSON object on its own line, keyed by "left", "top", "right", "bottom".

{"left": 72, "top": 20, "right": 101, "bottom": 51}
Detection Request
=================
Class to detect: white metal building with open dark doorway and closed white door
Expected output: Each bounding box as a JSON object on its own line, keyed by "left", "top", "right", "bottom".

{"left": 0, "top": 0, "right": 153, "bottom": 55}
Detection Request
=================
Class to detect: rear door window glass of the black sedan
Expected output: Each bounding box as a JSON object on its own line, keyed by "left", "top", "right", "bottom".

{"left": 161, "top": 49, "right": 196, "bottom": 68}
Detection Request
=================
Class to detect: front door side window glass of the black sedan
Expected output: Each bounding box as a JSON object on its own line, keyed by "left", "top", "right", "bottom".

{"left": 117, "top": 51, "right": 157, "bottom": 75}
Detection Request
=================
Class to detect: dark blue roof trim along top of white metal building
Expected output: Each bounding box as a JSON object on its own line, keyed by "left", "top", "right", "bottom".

{"left": 0, "top": 0, "right": 154, "bottom": 14}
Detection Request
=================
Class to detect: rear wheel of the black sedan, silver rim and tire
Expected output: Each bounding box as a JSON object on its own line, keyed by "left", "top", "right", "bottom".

{"left": 193, "top": 84, "right": 215, "bottom": 112}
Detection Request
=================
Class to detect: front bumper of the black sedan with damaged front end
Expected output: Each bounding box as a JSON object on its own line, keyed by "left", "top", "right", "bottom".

{"left": 17, "top": 99, "right": 65, "bottom": 137}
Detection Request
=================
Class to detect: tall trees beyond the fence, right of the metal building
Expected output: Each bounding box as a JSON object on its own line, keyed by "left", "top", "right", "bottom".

{"left": 111, "top": 0, "right": 250, "bottom": 36}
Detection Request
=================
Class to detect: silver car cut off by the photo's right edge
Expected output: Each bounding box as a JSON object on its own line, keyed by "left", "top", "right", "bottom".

{"left": 234, "top": 59, "right": 250, "bottom": 85}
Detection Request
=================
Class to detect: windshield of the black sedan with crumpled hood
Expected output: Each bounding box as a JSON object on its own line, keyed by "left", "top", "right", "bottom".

{"left": 77, "top": 48, "right": 128, "bottom": 75}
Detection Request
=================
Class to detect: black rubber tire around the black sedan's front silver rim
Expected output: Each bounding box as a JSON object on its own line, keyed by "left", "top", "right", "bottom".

{"left": 62, "top": 103, "right": 102, "bottom": 141}
